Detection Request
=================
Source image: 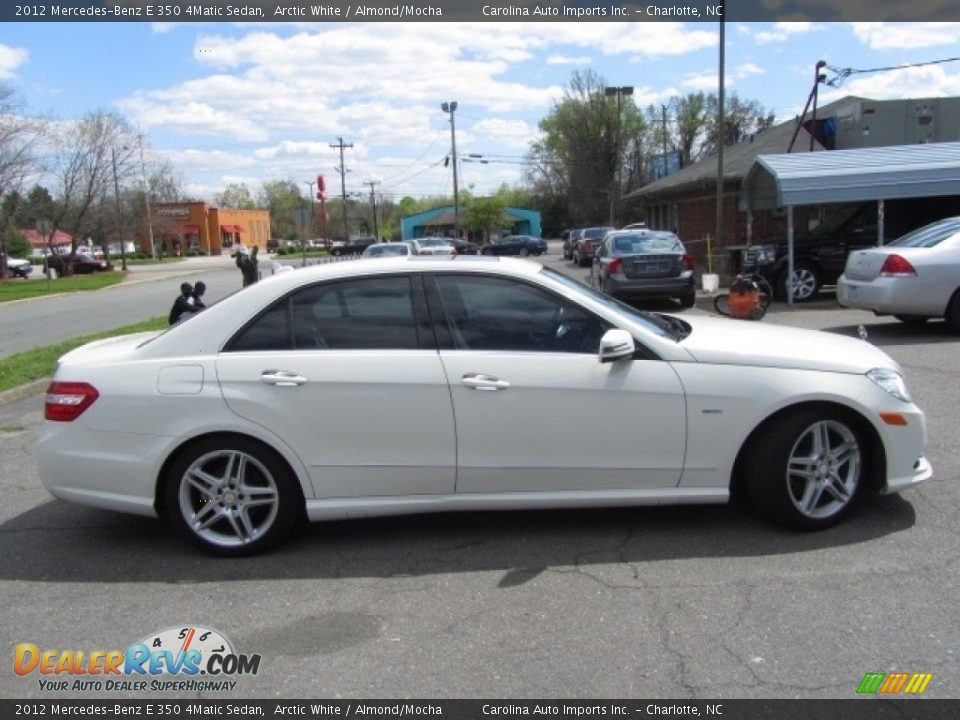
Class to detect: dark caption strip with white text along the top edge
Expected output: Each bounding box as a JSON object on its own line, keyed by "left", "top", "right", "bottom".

{"left": 0, "top": 0, "right": 960, "bottom": 23}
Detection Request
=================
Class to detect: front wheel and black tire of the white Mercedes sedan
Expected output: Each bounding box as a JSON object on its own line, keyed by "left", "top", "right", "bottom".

{"left": 743, "top": 407, "right": 871, "bottom": 530}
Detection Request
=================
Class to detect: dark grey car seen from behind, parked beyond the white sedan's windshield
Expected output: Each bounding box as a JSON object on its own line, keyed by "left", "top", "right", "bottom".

{"left": 590, "top": 230, "right": 697, "bottom": 308}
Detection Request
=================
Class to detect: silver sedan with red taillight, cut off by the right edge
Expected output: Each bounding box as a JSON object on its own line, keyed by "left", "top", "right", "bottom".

{"left": 837, "top": 217, "right": 960, "bottom": 332}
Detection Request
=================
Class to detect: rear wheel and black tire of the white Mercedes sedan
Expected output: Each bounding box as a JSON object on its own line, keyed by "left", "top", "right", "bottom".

{"left": 164, "top": 435, "right": 303, "bottom": 557}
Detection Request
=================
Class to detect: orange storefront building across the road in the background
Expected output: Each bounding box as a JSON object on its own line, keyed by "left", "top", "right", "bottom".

{"left": 148, "top": 201, "right": 270, "bottom": 255}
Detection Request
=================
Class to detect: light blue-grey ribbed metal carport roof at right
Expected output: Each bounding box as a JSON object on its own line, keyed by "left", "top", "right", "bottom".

{"left": 739, "top": 142, "right": 960, "bottom": 212}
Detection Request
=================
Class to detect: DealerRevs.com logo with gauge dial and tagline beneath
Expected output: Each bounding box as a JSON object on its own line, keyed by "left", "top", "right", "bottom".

{"left": 13, "top": 625, "right": 261, "bottom": 692}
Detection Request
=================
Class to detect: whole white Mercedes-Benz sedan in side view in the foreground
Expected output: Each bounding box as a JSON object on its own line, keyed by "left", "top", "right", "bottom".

{"left": 37, "top": 256, "right": 931, "bottom": 555}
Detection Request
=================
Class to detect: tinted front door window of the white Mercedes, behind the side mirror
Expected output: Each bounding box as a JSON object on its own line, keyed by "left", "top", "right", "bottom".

{"left": 436, "top": 275, "right": 607, "bottom": 353}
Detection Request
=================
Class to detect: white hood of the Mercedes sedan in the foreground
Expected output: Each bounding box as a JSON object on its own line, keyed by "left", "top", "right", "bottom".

{"left": 680, "top": 317, "right": 900, "bottom": 374}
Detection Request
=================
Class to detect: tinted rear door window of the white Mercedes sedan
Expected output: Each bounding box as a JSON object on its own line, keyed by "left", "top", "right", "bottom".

{"left": 229, "top": 276, "right": 420, "bottom": 351}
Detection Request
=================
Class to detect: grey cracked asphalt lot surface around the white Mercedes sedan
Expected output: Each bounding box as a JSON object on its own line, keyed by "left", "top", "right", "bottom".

{"left": 0, "top": 246, "right": 960, "bottom": 698}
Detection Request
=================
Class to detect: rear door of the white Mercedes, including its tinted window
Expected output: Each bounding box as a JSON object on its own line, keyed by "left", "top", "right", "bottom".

{"left": 217, "top": 275, "right": 456, "bottom": 498}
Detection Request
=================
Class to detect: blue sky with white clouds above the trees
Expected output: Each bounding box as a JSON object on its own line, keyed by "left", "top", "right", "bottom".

{"left": 0, "top": 21, "right": 960, "bottom": 205}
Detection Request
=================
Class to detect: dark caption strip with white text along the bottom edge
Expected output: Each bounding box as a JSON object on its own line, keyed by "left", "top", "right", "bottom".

{"left": 0, "top": 696, "right": 960, "bottom": 720}
